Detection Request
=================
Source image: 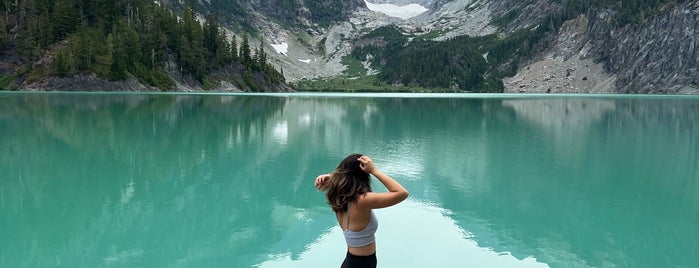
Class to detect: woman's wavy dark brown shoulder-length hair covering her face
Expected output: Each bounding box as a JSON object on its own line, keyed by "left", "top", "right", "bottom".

{"left": 321, "top": 154, "right": 371, "bottom": 212}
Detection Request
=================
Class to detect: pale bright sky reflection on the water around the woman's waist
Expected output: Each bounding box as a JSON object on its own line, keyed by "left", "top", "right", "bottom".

{"left": 256, "top": 200, "right": 548, "bottom": 268}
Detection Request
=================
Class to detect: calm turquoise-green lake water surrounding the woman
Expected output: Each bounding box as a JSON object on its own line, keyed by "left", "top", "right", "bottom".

{"left": 0, "top": 93, "right": 699, "bottom": 268}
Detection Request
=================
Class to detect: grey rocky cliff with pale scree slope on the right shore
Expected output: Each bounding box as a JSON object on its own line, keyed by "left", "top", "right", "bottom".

{"left": 491, "top": 0, "right": 699, "bottom": 94}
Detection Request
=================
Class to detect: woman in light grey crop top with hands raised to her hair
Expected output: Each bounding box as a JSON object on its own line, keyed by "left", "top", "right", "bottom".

{"left": 315, "top": 154, "right": 408, "bottom": 268}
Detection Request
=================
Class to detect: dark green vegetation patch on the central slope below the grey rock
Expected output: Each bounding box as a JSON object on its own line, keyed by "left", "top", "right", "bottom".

{"left": 352, "top": 26, "right": 545, "bottom": 92}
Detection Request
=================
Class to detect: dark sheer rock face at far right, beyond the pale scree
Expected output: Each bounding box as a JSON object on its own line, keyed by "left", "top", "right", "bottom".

{"left": 589, "top": 1, "right": 699, "bottom": 94}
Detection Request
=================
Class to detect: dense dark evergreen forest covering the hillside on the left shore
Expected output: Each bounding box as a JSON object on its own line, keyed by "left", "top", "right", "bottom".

{"left": 0, "top": 0, "right": 284, "bottom": 91}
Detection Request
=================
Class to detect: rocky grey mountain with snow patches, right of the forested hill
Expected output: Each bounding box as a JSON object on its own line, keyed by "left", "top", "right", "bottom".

{"left": 241, "top": 0, "right": 699, "bottom": 94}
